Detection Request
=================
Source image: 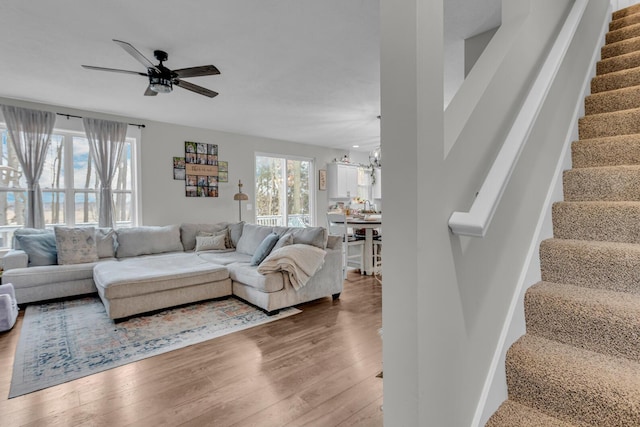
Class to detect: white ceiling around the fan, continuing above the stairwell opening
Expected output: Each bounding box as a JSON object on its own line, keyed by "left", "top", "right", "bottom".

{"left": 0, "top": 0, "right": 500, "bottom": 151}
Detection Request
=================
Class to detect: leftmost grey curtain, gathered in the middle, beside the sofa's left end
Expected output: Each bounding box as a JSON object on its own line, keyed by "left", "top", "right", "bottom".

{"left": 2, "top": 105, "right": 56, "bottom": 228}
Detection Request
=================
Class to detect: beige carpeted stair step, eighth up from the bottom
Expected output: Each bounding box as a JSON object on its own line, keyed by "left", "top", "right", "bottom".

{"left": 578, "top": 108, "right": 640, "bottom": 139}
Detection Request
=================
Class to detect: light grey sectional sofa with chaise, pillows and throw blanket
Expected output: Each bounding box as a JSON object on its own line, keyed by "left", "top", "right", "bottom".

{"left": 2, "top": 222, "right": 343, "bottom": 319}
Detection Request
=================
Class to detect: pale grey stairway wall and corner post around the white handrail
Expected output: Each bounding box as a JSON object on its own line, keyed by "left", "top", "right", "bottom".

{"left": 381, "top": 0, "right": 608, "bottom": 426}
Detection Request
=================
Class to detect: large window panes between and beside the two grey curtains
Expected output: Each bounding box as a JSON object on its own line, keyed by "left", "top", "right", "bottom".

{"left": 0, "top": 123, "right": 137, "bottom": 248}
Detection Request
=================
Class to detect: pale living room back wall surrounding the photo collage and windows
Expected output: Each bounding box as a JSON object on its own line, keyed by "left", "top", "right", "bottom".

{"left": 0, "top": 98, "right": 344, "bottom": 225}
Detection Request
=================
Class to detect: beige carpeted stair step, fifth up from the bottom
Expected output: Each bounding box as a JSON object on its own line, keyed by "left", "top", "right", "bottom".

{"left": 552, "top": 202, "right": 640, "bottom": 243}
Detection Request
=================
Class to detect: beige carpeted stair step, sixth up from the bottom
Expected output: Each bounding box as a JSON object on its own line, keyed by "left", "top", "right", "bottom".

{"left": 563, "top": 165, "right": 640, "bottom": 201}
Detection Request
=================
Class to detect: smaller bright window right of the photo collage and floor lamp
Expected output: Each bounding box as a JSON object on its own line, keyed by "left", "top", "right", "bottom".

{"left": 256, "top": 154, "right": 315, "bottom": 227}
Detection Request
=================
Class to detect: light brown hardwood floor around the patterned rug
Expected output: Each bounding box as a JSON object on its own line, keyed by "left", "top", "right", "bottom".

{"left": 0, "top": 273, "right": 382, "bottom": 427}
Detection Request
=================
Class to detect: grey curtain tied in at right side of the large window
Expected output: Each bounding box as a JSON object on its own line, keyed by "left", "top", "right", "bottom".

{"left": 82, "top": 118, "right": 127, "bottom": 227}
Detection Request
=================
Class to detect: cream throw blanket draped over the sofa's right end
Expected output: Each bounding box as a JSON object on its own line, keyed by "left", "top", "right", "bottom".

{"left": 258, "top": 244, "right": 327, "bottom": 290}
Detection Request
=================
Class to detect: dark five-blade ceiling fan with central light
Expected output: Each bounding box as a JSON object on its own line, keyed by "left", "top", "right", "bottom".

{"left": 83, "top": 39, "right": 220, "bottom": 98}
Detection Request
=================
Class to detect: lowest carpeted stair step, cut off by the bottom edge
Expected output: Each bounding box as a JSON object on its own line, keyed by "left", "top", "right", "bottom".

{"left": 485, "top": 399, "right": 577, "bottom": 427}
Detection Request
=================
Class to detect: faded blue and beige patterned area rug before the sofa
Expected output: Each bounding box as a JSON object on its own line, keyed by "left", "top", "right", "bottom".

{"left": 9, "top": 297, "right": 300, "bottom": 398}
